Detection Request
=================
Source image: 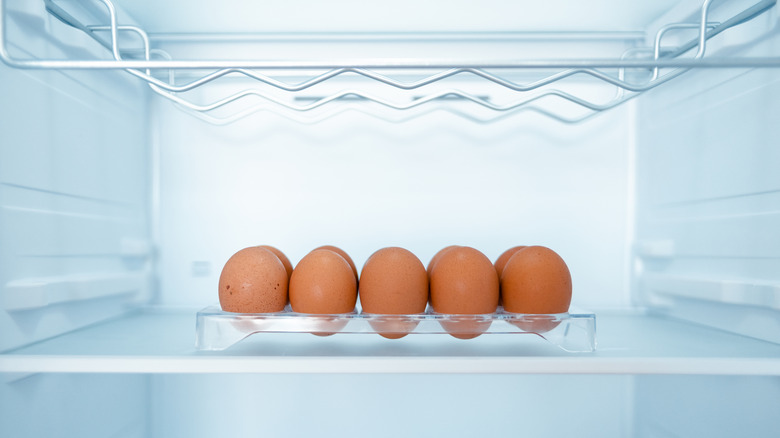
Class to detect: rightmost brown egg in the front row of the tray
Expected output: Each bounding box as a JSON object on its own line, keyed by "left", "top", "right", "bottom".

{"left": 501, "top": 246, "right": 572, "bottom": 332}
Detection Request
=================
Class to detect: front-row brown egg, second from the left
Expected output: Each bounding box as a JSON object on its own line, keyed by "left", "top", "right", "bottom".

{"left": 290, "top": 249, "right": 357, "bottom": 335}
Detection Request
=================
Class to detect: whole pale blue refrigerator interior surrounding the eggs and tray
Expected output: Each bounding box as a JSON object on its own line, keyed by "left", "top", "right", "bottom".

{"left": 0, "top": 0, "right": 780, "bottom": 437}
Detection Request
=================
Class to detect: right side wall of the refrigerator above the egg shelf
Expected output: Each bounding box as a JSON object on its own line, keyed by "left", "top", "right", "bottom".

{"left": 634, "top": 13, "right": 780, "bottom": 342}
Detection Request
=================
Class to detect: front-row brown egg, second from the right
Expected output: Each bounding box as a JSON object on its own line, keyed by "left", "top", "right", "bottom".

{"left": 430, "top": 246, "right": 498, "bottom": 339}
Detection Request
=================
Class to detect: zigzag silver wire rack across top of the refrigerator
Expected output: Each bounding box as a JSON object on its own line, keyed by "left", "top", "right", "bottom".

{"left": 0, "top": 0, "right": 780, "bottom": 124}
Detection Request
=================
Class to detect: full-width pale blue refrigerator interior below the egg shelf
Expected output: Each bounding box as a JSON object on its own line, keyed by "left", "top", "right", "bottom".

{"left": 6, "top": 374, "right": 780, "bottom": 438}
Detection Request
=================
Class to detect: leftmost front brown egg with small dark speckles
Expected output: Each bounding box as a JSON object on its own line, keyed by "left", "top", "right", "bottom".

{"left": 219, "top": 247, "right": 288, "bottom": 313}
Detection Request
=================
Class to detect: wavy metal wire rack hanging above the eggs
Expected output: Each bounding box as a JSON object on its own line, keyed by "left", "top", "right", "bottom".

{"left": 0, "top": 0, "right": 780, "bottom": 124}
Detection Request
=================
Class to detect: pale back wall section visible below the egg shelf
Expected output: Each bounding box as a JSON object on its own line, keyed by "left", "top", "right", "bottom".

{"left": 150, "top": 374, "right": 633, "bottom": 438}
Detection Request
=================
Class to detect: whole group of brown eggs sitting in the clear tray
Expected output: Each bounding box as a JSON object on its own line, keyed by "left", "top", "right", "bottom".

{"left": 219, "top": 245, "right": 572, "bottom": 324}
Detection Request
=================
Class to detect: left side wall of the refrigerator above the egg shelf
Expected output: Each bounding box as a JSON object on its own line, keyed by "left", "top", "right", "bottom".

{"left": 0, "top": 3, "right": 152, "bottom": 351}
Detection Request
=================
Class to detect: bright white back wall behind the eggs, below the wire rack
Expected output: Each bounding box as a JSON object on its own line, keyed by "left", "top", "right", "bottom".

{"left": 157, "top": 87, "right": 632, "bottom": 307}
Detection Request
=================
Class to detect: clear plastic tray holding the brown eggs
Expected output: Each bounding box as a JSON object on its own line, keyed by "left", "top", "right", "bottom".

{"left": 195, "top": 305, "right": 596, "bottom": 353}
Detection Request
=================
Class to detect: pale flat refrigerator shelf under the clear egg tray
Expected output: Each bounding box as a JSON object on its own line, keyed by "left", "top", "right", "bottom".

{"left": 0, "top": 308, "right": 780, "bottom": 374}
